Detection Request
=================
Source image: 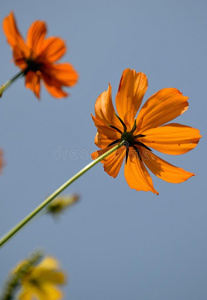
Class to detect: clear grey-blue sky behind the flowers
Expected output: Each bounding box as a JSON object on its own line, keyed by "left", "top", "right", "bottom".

{"left": 0, "top": 0, "right": 207, "bottom": 300}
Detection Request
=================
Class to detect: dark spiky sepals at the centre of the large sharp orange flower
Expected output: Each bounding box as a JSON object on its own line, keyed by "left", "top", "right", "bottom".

{"left": 108, "top": 114, "right": 152, "bottom": 163}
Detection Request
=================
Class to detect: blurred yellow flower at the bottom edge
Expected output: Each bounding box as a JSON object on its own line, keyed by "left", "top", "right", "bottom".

{"left": 16, "top": 257, "right": 66, "bottom": 300}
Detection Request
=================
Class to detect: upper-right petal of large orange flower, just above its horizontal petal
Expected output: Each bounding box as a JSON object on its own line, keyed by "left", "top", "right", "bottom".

{"left": 137, "top": 88, "right": 188, "bottom": 132}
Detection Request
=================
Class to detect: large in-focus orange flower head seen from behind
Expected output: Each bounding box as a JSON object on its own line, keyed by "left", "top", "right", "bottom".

{"left": 92, "top": 69, "right": 201, "bottom": 194}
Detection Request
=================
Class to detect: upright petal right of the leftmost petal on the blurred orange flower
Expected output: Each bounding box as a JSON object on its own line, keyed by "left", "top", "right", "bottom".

{"left": 27, "top": 21, "right": 47, "bottom": 54}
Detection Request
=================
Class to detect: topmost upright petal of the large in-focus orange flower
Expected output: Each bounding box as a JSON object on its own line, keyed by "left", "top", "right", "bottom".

{"left": 116, "top": 69, "right": 148, "bottom": 127}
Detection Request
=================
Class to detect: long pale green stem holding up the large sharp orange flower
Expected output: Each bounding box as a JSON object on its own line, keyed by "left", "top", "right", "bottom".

{"left": 0, "top": 141, "right": 124, "bottom": 247}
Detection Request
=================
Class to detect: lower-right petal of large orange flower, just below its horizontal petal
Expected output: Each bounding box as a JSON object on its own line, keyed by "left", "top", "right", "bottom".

{"left": 144, "top": 152, "right": 195, "bottom": 183}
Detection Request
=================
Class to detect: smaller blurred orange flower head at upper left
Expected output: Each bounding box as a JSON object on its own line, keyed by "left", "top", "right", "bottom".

{"left": 3, "top": 12, "right": 78, "bottom": 98}
